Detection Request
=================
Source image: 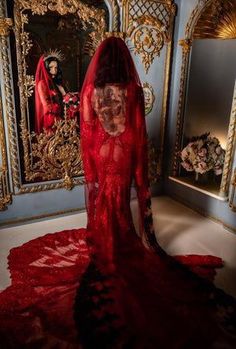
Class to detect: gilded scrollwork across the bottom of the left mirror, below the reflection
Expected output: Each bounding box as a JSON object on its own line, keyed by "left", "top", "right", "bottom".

{"left": 22, "top": 119, "right": 83, "bottom": 189}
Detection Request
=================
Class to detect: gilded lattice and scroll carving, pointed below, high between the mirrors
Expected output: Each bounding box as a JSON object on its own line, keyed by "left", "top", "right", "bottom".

{"left": 123, "top": 0, "right": 176, "bottom": 73}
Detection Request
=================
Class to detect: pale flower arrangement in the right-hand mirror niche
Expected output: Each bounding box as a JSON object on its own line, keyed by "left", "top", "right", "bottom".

{"left": 180, "top": 132, "right": 225, "bottom": 176}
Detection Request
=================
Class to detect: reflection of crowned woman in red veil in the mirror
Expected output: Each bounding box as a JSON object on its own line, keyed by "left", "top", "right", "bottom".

{"left": 35, "top": 51, "right": 66, "bottom": 133}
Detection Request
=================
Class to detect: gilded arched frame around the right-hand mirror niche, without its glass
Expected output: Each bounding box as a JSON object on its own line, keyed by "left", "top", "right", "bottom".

{"left": 172, "top": 0, "right": 236, "bottom": 198}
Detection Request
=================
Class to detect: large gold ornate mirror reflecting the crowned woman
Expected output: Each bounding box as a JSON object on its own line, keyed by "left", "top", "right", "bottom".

{"left": 4, "top": 0, "right": 112, "bottom": 192}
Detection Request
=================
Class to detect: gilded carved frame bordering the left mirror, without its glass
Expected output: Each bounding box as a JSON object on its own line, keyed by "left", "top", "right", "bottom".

{"left": 0, "top": 0, "right": 119, "bottom": 195}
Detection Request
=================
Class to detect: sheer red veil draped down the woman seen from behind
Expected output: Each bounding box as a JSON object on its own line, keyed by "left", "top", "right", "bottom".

{"left": 81, "top": 37, "right": 159, "bottom": 250}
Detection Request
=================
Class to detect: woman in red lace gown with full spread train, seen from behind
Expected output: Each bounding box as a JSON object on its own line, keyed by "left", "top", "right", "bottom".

{"left": 0, "top": 38, "right": 236, "bottom": 349}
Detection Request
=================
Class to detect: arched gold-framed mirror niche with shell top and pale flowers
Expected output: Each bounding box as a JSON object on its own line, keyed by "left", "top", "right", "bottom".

{"left": 173, "top": 0, "right": 236, "bottom": 197}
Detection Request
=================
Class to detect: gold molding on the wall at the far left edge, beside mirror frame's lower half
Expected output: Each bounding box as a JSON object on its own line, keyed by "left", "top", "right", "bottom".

{"left": 0, "top": 97, "right": 12, "bottom": 211}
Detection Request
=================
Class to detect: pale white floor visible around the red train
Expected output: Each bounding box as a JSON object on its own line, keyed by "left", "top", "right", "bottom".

{"left": 0, "top": 196, "right": 236, "bottom": 297}
